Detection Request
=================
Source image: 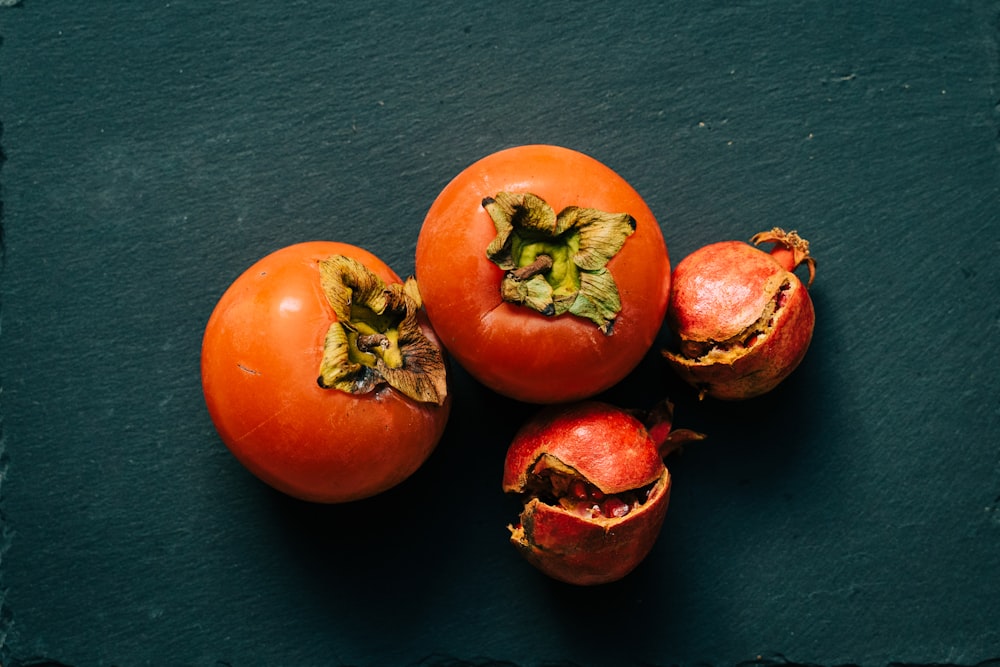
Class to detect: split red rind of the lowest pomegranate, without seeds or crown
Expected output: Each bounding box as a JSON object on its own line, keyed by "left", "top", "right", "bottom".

{"left": 503, "top": 401, "right": 671, "bottom": 586}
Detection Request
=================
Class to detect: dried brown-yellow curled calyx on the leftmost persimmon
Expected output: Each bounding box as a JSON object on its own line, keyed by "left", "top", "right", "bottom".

{"left": 318, "top": 255, "right": 448, "bottom": 405}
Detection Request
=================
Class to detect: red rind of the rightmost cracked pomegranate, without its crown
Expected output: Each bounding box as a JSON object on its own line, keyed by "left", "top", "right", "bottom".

{"left": 666, "top": 241, "right": 816, "bottom": 401}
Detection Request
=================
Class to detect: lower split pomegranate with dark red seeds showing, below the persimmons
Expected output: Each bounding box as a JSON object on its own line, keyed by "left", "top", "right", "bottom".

{"left": 503, "top": 401, "right": 703, "bottom": 585}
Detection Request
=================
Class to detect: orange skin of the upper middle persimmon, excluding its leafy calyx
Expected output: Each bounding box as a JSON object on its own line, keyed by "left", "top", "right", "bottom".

{"left": 416, "top": 145, "right": 670, "bottom": 404}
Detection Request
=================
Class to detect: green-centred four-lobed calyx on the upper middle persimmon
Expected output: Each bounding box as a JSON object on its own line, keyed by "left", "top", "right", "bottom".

{"left": 483, "top": 192, "right": 636, "bottom": 335}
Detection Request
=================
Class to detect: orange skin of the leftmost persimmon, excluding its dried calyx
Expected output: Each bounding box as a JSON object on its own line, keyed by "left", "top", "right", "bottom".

{"left": 201, "top": 241, "right": 450, "bottom": 503}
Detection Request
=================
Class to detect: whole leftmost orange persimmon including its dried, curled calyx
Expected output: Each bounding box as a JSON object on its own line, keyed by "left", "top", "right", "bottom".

{"left": 201, "top": 241, "right": 451, "bottom": 503}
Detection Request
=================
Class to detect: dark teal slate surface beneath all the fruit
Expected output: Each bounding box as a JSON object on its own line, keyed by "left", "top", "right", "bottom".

{"left": 0, "top": 0, "right": 1000, "bottom": 667}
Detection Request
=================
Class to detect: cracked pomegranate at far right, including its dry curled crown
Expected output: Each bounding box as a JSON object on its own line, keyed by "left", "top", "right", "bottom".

{"left": 663, "top": 227, "right": 816, "bottom": 400}
